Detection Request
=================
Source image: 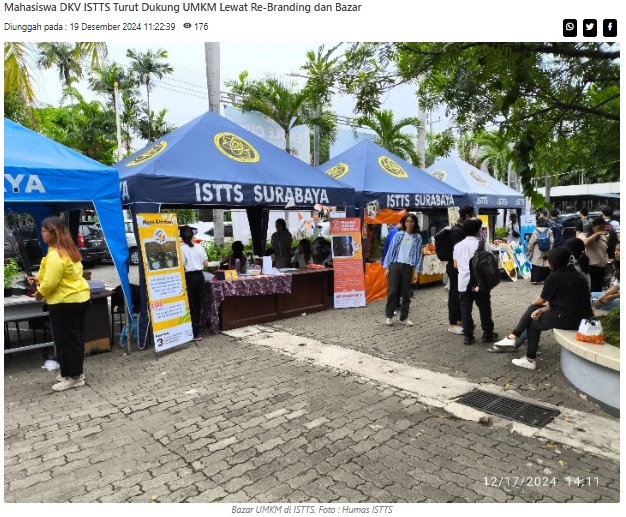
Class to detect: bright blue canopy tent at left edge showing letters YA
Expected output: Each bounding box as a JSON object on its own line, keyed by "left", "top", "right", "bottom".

{"left": 4, "top": 118, "right": 132, "bottom": 311}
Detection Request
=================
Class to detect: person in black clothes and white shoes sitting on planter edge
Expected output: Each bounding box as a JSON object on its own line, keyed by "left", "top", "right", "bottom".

{"left": 495, "top": 246, "right": 591, "bottom": 370}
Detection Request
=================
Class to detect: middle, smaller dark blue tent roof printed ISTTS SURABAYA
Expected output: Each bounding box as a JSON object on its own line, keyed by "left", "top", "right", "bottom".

{"left": 318, "top": 140, "right": 467, "bottom": 209}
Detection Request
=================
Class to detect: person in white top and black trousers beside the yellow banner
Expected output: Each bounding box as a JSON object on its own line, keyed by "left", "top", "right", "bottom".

{"left": 180, "top": 226, "right": 209, "bottom": 341}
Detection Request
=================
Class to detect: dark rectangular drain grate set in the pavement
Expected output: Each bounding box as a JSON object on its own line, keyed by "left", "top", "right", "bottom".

{"left": 457, "top": 390, "right": 560, "bottom": 427}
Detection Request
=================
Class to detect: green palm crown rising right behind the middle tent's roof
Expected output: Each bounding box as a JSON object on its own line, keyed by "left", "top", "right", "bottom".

{"left": 356, "top": 110, "right": 422, "bottom": 166}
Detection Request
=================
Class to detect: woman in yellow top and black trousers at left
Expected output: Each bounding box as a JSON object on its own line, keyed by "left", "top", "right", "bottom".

{"left": 28, "top": 216, "right": 90, "bottom": 391}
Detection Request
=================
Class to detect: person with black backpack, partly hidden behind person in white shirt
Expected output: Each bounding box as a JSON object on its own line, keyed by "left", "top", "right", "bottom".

{"left": 435, "top": 205, "right": 476, "bottom": 335}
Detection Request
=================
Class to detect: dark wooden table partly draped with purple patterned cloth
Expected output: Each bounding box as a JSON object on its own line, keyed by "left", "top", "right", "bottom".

{"left": 200, "top": 268, "right": 329, "bottom": 334}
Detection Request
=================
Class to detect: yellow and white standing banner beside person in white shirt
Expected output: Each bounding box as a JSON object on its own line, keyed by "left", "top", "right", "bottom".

{"left": 137, "top": 214, "right": 193, "bottom": 352}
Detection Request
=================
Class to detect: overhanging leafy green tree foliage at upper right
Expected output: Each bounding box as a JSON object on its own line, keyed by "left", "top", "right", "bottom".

{"left": 339, "top": 42, "right": 620, "bottom": 205}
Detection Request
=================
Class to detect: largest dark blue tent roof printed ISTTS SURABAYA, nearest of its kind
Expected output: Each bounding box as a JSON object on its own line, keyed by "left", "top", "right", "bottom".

{"left": 115, "top": 112, "right": 354, "bottom": 208}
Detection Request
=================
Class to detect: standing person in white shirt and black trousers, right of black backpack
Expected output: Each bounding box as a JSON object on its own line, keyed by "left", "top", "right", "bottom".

{"left": 453, "top": 218, "right": 498, "bottom": 345}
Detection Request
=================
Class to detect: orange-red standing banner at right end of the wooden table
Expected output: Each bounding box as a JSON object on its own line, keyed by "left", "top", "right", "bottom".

{"left": 330, "top": 217, "right": 365, "bottom": 309}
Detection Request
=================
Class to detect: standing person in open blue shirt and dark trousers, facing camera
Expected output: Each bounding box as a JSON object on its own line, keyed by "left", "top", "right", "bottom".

{"left": 383, "top": 213, "right": 422, "bottom": 327}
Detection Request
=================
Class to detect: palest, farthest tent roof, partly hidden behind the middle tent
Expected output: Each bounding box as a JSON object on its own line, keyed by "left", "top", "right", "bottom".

{"left": 426, "top": 156, "right": 525, "bottom": 208}
